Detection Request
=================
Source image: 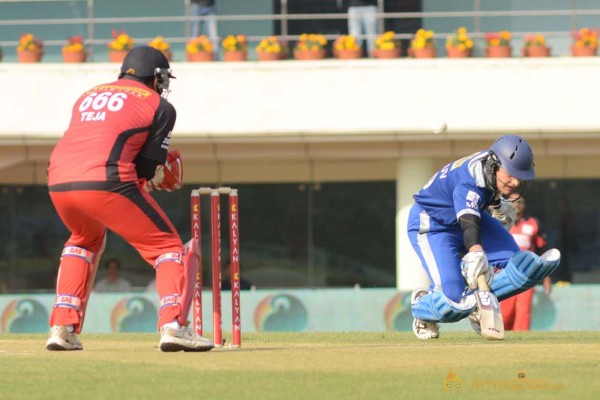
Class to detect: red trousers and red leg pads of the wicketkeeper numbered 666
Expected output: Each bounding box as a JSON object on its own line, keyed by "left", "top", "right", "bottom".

{"left": 50, "top": 182, "right": 185, "bottom": 332}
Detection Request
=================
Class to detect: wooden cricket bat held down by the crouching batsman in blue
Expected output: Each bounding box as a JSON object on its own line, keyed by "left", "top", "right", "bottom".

{"left": 475, "top": 275, "right": 504, "bottom": 340}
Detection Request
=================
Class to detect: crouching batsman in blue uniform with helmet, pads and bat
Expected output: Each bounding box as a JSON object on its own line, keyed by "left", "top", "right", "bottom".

{"left": 408, "top": 135, "right": 560, "bottom": 339}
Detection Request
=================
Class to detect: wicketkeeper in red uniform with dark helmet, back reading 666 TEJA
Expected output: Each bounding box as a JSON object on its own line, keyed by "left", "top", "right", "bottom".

{"left": 46, "top": 46, "right": 213, "bottom": 351}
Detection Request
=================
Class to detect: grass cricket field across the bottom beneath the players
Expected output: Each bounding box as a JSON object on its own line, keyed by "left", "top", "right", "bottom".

{"left": 0, "top": 332, "right": 600, "bottom": 400}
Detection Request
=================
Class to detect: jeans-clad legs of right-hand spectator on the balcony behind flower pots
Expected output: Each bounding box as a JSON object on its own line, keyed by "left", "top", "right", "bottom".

{"left": 348, "top": 0, "right": 377, "bottom": 57}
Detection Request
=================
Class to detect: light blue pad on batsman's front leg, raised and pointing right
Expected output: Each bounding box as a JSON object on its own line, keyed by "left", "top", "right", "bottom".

{"left": 490, "top": 249, "right": 560, "bottom": 301}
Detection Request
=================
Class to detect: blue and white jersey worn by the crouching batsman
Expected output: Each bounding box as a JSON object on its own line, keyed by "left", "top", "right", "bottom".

{"left": 414, "top": 151, "right": 494, "bottom": 232}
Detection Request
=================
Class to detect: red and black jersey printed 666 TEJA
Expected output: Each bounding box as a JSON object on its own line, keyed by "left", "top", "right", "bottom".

{"left": 48, "top": 79, "right": 176, "bottom": 186}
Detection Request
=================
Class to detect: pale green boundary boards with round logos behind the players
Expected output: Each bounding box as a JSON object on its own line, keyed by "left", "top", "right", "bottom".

{"left": 0, "top": 285, "right": 600, "bottom": 334}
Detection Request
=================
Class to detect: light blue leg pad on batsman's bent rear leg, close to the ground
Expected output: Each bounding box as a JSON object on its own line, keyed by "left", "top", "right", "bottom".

{"left": 411, "top": 290, "right": 477, "bottom": 322}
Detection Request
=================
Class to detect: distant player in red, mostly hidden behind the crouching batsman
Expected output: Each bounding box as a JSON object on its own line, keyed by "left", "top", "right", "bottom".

{"left": 500, "top": 197, "right": 552, "bottom": 331}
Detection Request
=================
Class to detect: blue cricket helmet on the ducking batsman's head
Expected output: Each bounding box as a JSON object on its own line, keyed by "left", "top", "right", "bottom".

{"left": 489, "top": 135, "right": 535, "bottom": 180}
